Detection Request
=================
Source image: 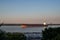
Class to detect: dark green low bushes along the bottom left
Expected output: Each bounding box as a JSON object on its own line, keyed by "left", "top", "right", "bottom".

{"left": 0, "top": 30, "right": 26, "bottom": 40}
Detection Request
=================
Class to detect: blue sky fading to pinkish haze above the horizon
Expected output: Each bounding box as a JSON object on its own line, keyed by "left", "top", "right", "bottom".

{"left": 0, "top": 0, "right": 60, "bottom": 24}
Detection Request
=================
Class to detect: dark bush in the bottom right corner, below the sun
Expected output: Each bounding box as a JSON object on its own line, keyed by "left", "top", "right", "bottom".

{"left": 42, "top": 27, "right": 60, "bottom": 40}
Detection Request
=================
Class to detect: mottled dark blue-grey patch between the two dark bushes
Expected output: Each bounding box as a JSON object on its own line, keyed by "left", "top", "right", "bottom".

{"left": 24, "top": 32, "right": 42, "bottom": 40}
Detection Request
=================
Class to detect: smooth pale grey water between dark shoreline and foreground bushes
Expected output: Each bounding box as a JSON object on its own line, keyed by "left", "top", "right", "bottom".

{"left": 0, "top": 26, "right": 44, "bottom": 32}
